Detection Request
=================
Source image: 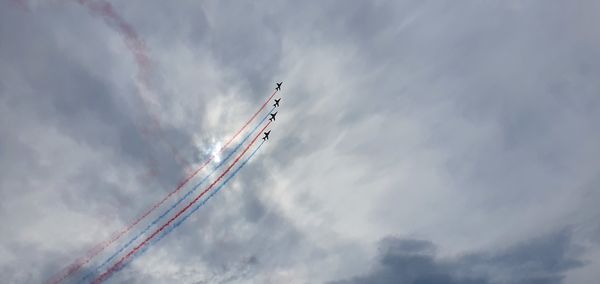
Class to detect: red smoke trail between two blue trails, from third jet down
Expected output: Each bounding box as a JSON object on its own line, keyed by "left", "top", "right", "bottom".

{"left": 92, "top": 121, "right": 271, "bottom": 284}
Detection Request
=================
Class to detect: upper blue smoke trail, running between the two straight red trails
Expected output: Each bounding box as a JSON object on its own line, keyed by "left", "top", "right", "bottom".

{"left": 81, "top": 107, "right": 275, "bottom": 281}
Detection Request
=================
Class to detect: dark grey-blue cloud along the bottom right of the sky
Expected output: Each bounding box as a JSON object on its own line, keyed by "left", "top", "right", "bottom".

{"left": 334, "top": 230, "right": 583, "bottom": 284}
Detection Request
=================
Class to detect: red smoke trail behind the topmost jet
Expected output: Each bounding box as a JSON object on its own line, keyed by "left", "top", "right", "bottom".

{"left": 47, "top": 91, "right": 277, "bottom": 284}
